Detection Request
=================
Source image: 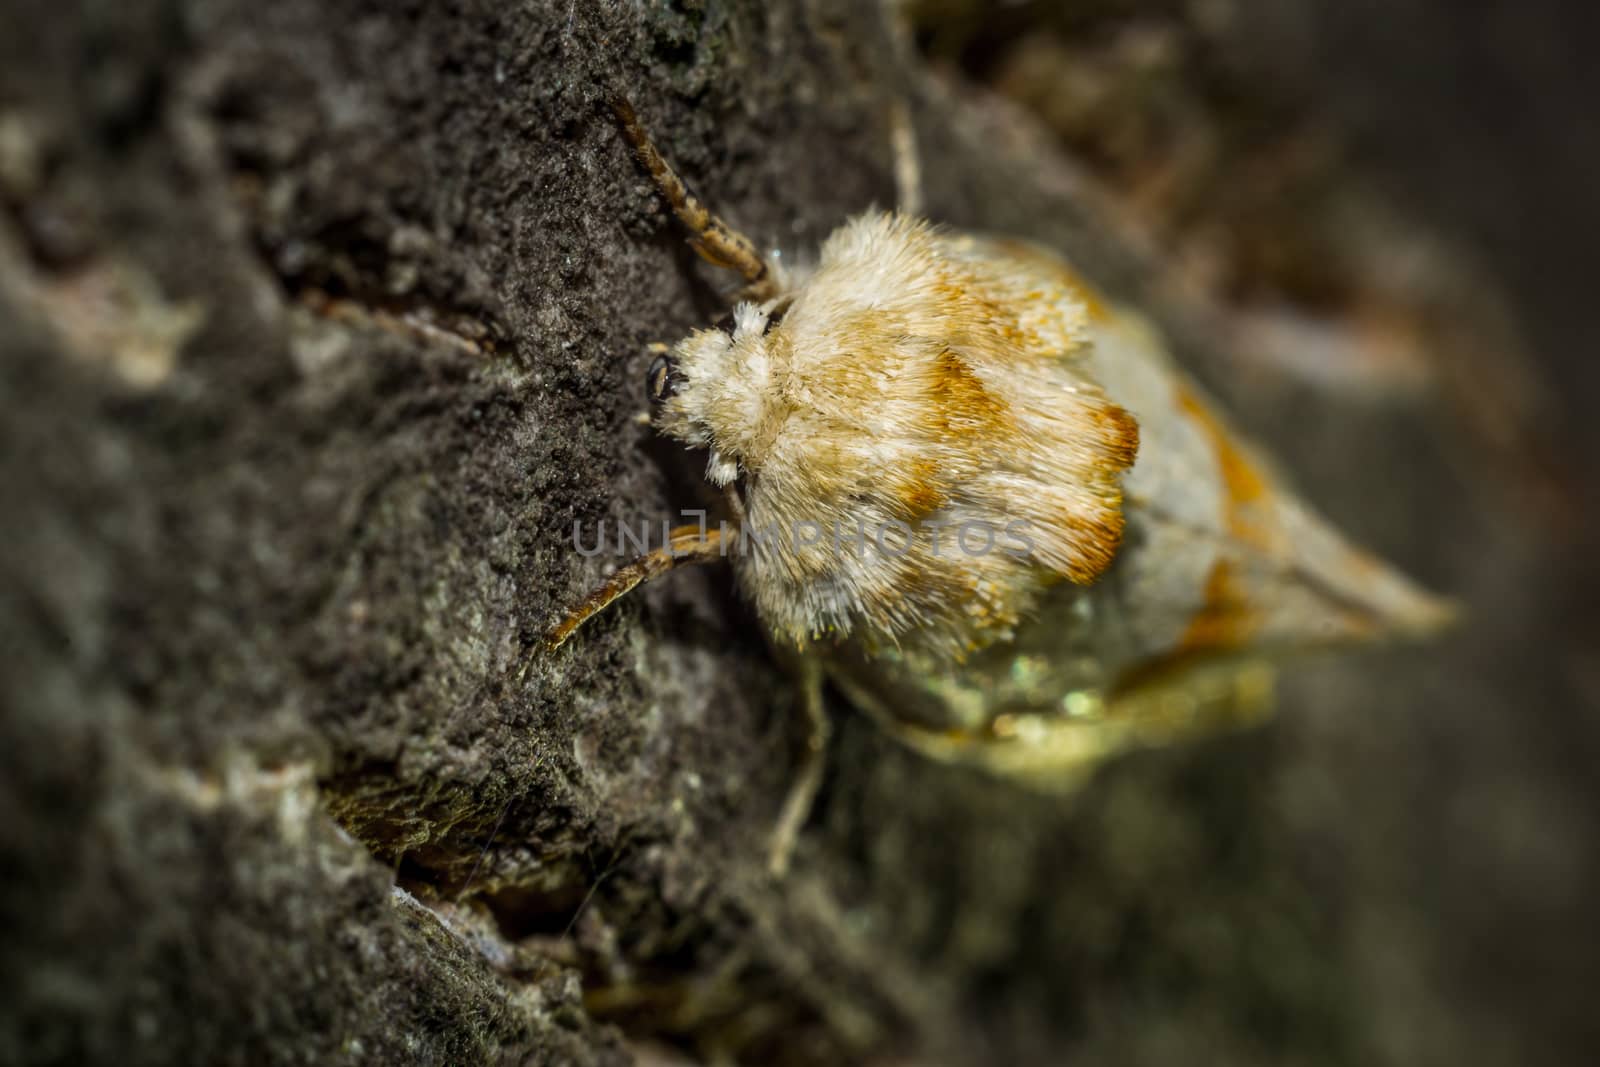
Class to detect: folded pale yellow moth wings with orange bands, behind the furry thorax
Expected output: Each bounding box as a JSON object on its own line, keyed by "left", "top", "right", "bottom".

{"left": 829, "top": 242, "right": 1454, "bottom": 789}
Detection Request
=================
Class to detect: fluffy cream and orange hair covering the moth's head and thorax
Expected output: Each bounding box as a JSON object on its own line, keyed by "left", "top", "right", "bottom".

{"left": 658, "top": 213, "right": 1138, "bottom": 657}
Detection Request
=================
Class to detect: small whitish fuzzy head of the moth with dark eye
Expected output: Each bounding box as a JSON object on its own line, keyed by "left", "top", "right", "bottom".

{"left": 645, "top": 301, "right": 784, "bottom": 485}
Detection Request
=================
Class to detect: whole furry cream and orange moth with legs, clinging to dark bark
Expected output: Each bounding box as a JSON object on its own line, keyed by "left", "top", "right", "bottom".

{"left": 544, "top": 95, "right": 1451, "bottom": 873}
